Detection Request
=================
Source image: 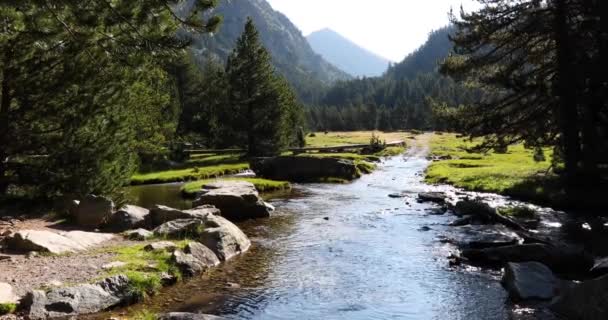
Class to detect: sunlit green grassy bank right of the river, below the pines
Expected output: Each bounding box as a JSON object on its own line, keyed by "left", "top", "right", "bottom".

{"left": 426, "top": 134, "right": 561, "bottom": 203}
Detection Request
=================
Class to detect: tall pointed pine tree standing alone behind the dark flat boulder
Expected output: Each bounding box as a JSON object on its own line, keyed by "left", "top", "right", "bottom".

{"left": 226, "top": 19, "right": 300, "bottom": 156}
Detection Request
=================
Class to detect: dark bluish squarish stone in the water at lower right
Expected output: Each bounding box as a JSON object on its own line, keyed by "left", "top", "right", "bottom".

{"left": 501, "top": 262, "right": 560, "bottom": 302}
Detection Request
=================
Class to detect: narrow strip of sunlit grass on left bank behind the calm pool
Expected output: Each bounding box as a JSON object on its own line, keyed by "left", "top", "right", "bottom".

{"left": 131, "top": 163, "right": 249, "bottom": 185}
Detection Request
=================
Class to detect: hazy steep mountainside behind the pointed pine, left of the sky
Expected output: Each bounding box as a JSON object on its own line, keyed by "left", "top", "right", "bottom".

{"left": 191, "top": 0, "right": 351, "bottom": 102}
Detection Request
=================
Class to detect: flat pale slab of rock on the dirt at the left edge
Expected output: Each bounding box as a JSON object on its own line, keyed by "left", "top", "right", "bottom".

{"left": 4, "top": 230, "right": 114, "bottom": 254}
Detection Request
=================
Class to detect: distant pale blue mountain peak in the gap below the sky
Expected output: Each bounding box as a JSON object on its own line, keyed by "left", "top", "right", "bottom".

{"left": 306, "top": 29, "right": 390, "bottom": 77}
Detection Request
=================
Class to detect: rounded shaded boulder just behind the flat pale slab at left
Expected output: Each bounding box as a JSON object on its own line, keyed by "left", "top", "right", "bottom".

{"left": 74, "top": 195, "right": 114, "bottom": 228}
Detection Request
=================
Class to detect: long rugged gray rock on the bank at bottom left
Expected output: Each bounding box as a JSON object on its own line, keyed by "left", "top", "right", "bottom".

{"left": 21, "top": 275, "right": 134, "bottom": 320}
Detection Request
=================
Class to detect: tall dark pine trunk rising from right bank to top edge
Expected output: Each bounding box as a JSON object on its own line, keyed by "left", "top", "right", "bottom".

{"left": 553, "top": 0, "right": 581, "bottom": 186}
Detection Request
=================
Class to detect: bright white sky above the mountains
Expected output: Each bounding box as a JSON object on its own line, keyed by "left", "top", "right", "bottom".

{"left": 268, "top": 0, "right": 477, "bottom": 62}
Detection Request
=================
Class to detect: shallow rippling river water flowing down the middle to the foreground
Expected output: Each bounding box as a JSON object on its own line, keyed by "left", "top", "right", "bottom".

{"left": 117, "top": 153, "right": 509, "bottom": 320}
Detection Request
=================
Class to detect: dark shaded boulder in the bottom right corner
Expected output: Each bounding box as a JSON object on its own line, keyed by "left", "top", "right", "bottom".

{"left": 550, "top": 275, "right": 608, "bottom": 320}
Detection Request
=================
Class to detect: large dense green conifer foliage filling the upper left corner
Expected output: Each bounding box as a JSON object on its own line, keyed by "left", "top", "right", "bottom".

{"left": 0, "top": 0, "right": 220, "bottom": 197}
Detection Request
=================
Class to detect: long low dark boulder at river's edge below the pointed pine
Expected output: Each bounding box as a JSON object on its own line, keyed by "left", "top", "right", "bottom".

{"left": 251, "top": 156, "right": 361, "bottom": 182}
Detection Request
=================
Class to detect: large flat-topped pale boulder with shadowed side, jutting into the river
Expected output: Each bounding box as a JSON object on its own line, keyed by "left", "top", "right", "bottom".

{"left": 193, "top": 180, "right": 271, "bottom": 220}
